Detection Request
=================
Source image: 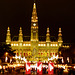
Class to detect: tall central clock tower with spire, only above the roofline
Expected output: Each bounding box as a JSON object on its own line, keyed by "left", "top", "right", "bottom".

{"left": 31, "top": 3, "right": 38, "bottom": 41}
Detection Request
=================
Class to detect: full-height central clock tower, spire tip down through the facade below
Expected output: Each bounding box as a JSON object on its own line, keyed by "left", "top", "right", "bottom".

{"left": 31, "top": 3, "right": 39, "bottom": 61}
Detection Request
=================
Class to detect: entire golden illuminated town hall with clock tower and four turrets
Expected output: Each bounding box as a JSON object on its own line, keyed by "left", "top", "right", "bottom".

{"left": 6, "top": 3, "right": 63, "bottom": 61}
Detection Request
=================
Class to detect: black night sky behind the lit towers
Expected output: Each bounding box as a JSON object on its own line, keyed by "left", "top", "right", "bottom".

{"left": 0, "top": 0, "right": 75, "bottom": 43}
